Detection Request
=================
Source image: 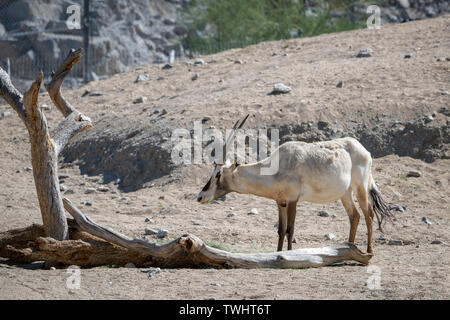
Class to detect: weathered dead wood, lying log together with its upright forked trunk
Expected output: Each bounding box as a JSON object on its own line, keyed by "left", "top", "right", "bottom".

{"left": 0, "top": 49, "right": 372, "bottom": 268}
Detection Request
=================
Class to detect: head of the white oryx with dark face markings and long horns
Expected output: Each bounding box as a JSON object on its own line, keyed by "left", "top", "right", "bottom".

{"left": 197, "top": 115, "right": 249, "bottom": 203}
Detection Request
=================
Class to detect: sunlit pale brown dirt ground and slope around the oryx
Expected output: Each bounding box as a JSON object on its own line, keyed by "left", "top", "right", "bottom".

{"left": 0, "top": 15, "right": 450, "bottom": 299}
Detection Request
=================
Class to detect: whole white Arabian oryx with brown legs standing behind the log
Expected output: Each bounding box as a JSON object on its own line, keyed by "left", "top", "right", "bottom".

{"left": 197, "top": 116, "right": 392, "bottom": 255}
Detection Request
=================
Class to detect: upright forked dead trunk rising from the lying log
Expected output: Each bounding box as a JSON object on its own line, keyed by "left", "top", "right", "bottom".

{"left": 0, "top": 49, "right": 91, "bottom": 240}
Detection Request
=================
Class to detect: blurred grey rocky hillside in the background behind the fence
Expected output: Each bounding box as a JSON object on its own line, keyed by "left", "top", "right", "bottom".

{"left": 0, "top": 0, "right": 450, "bottom": 84}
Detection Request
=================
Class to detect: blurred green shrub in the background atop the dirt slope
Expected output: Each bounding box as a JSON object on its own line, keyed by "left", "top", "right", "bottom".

{"left": 183, "top": 0, "right": 367, "bottom": 54}
